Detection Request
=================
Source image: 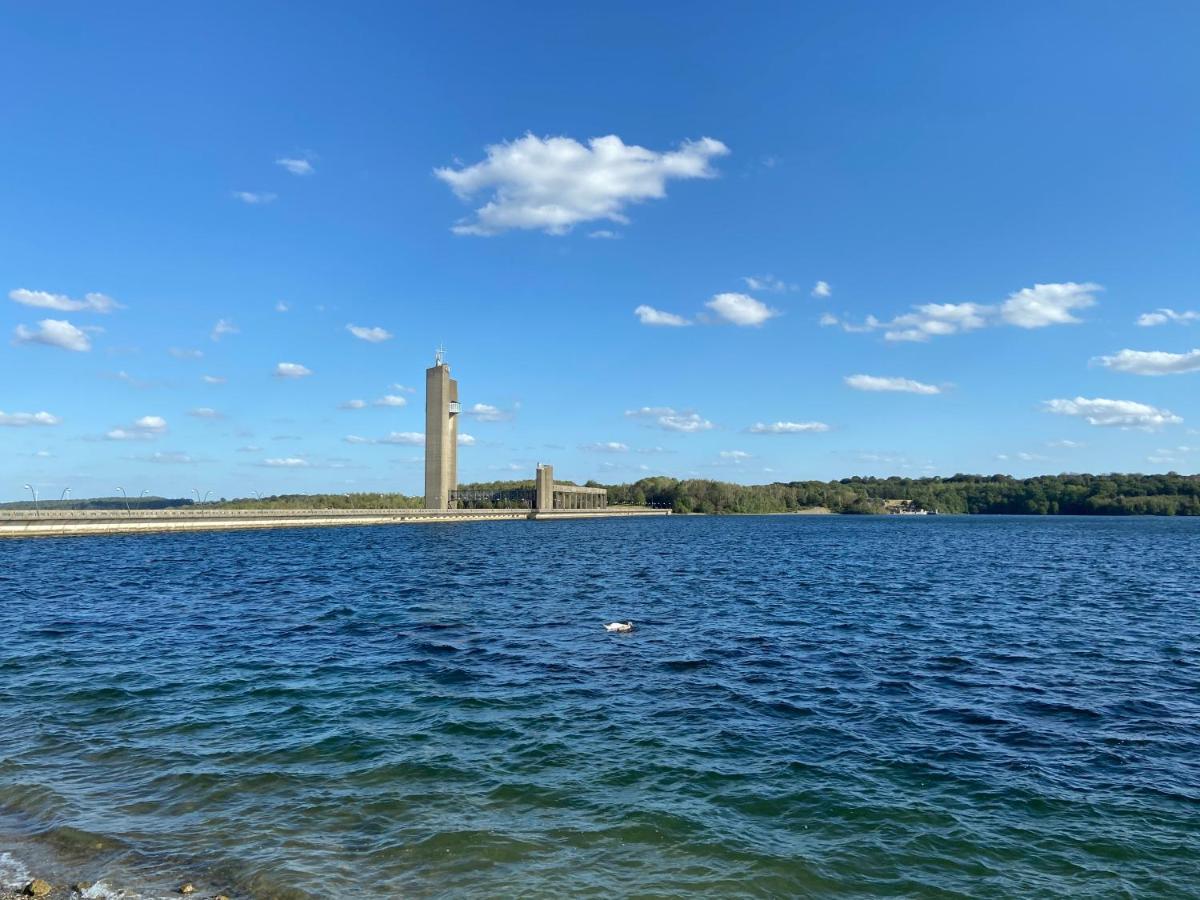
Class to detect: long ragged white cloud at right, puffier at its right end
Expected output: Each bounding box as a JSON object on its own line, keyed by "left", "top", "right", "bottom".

{"left": 821, "top": 282, "right": 1103, "bottom": 341}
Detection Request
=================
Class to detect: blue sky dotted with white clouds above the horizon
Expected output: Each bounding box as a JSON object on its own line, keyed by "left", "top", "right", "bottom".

{"left": 0, "top": 2, "right": 1200, "bottom": 499}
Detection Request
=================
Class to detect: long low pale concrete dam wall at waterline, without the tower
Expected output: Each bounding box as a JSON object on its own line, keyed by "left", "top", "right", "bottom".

{"left": 0, "top": 506, "right": 670, "bottom": 538}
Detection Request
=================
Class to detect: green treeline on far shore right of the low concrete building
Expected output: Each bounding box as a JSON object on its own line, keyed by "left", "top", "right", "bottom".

{"left": 608, "top": 473, "right": 1200, "bottom": 516}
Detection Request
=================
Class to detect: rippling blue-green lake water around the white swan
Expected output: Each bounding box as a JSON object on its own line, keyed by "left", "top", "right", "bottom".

{"left": 0, "top": 516, "right": 1200, "bottom": 898}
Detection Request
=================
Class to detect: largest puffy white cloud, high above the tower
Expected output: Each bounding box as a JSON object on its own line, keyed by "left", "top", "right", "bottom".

{"left": 433, "top": 134, "right": 730, "bottom": 235}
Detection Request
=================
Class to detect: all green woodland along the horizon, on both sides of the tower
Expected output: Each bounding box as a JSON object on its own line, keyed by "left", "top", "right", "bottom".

{"left": 0, "top": 473, "right": 1200, "bottom": 516}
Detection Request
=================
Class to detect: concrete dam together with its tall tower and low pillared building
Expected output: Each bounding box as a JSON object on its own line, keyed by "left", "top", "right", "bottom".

{"left": 0, "top": 349, "right": 671, "bottom": 538}
